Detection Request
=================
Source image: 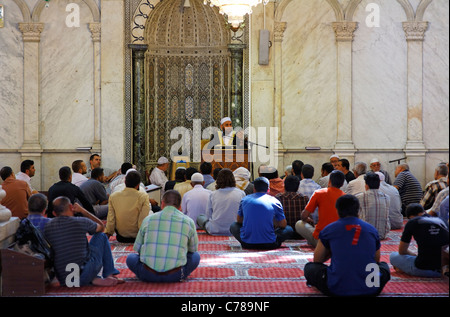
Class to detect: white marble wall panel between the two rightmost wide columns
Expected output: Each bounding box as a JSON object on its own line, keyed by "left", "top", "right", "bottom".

{"left": 352, "top": 0, "right": 407, "bottom": 149}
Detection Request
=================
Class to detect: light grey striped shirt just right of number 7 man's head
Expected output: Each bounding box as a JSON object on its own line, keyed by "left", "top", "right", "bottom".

{"left": 356, "top": 189, "right": 391, "bottom": 240}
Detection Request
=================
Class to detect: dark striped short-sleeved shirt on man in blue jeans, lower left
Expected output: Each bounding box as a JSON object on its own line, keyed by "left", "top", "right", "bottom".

{"left": 44, "top": 216, "right": 97, "bottom": 285}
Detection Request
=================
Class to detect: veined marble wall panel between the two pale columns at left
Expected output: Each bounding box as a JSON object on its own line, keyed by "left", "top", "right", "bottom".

{"left": 39, "top": 0, "right": 94, "bottom": 149}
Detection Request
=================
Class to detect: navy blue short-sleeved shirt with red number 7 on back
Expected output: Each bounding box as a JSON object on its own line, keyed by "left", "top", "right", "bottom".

{"left": 319, "top": 217, "right": 381, "bottom": 296}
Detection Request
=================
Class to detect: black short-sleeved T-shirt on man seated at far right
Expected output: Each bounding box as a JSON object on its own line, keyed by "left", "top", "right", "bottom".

{"left": 401, "top": 215, "right": 448, "bottom": 270}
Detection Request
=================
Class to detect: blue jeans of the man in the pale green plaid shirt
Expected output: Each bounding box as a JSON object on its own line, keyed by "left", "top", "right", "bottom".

{"left": 127, "top": 252, "right": 200, "bottom": 283}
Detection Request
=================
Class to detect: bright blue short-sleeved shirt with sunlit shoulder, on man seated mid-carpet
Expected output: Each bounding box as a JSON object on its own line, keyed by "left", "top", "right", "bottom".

{"left": 238, "top": 193, "right": 285, "bottom": 244}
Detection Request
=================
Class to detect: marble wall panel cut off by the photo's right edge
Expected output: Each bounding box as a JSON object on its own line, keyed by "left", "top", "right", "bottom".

{"left": 423, "top": 0, "right": 449, "bottom": 149}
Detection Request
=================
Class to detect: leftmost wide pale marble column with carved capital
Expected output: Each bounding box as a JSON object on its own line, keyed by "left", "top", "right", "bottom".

{"left": 19, "top": 23, "right": 44, "bottom": 190}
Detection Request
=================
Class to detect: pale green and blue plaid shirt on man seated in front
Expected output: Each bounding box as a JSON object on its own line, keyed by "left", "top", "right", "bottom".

{"left": 134, "top": 206, "right": 198, "bottom": 272}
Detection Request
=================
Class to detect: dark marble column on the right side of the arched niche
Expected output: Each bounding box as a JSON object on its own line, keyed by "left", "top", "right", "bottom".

{"left": 228, "top": 44, "right": 247, "bottom": 128}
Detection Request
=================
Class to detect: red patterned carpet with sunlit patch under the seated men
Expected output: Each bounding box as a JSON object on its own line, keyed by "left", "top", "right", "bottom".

{"left": 41, "top": 223, "right": 449, "bottom": 297}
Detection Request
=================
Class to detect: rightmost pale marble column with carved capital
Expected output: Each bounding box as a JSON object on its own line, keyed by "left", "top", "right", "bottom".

{"left": 403, "top": 21, "right": 428, "bottom": 185}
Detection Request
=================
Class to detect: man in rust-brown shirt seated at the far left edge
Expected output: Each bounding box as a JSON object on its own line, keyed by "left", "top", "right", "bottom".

{"left": 0, "top": 166, "right": 31, "bottom": 220}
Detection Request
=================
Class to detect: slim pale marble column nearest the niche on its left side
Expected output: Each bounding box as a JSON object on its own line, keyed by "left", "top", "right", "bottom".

{"left": 89, "top": 22, "right": 101, "bottom": 153}
